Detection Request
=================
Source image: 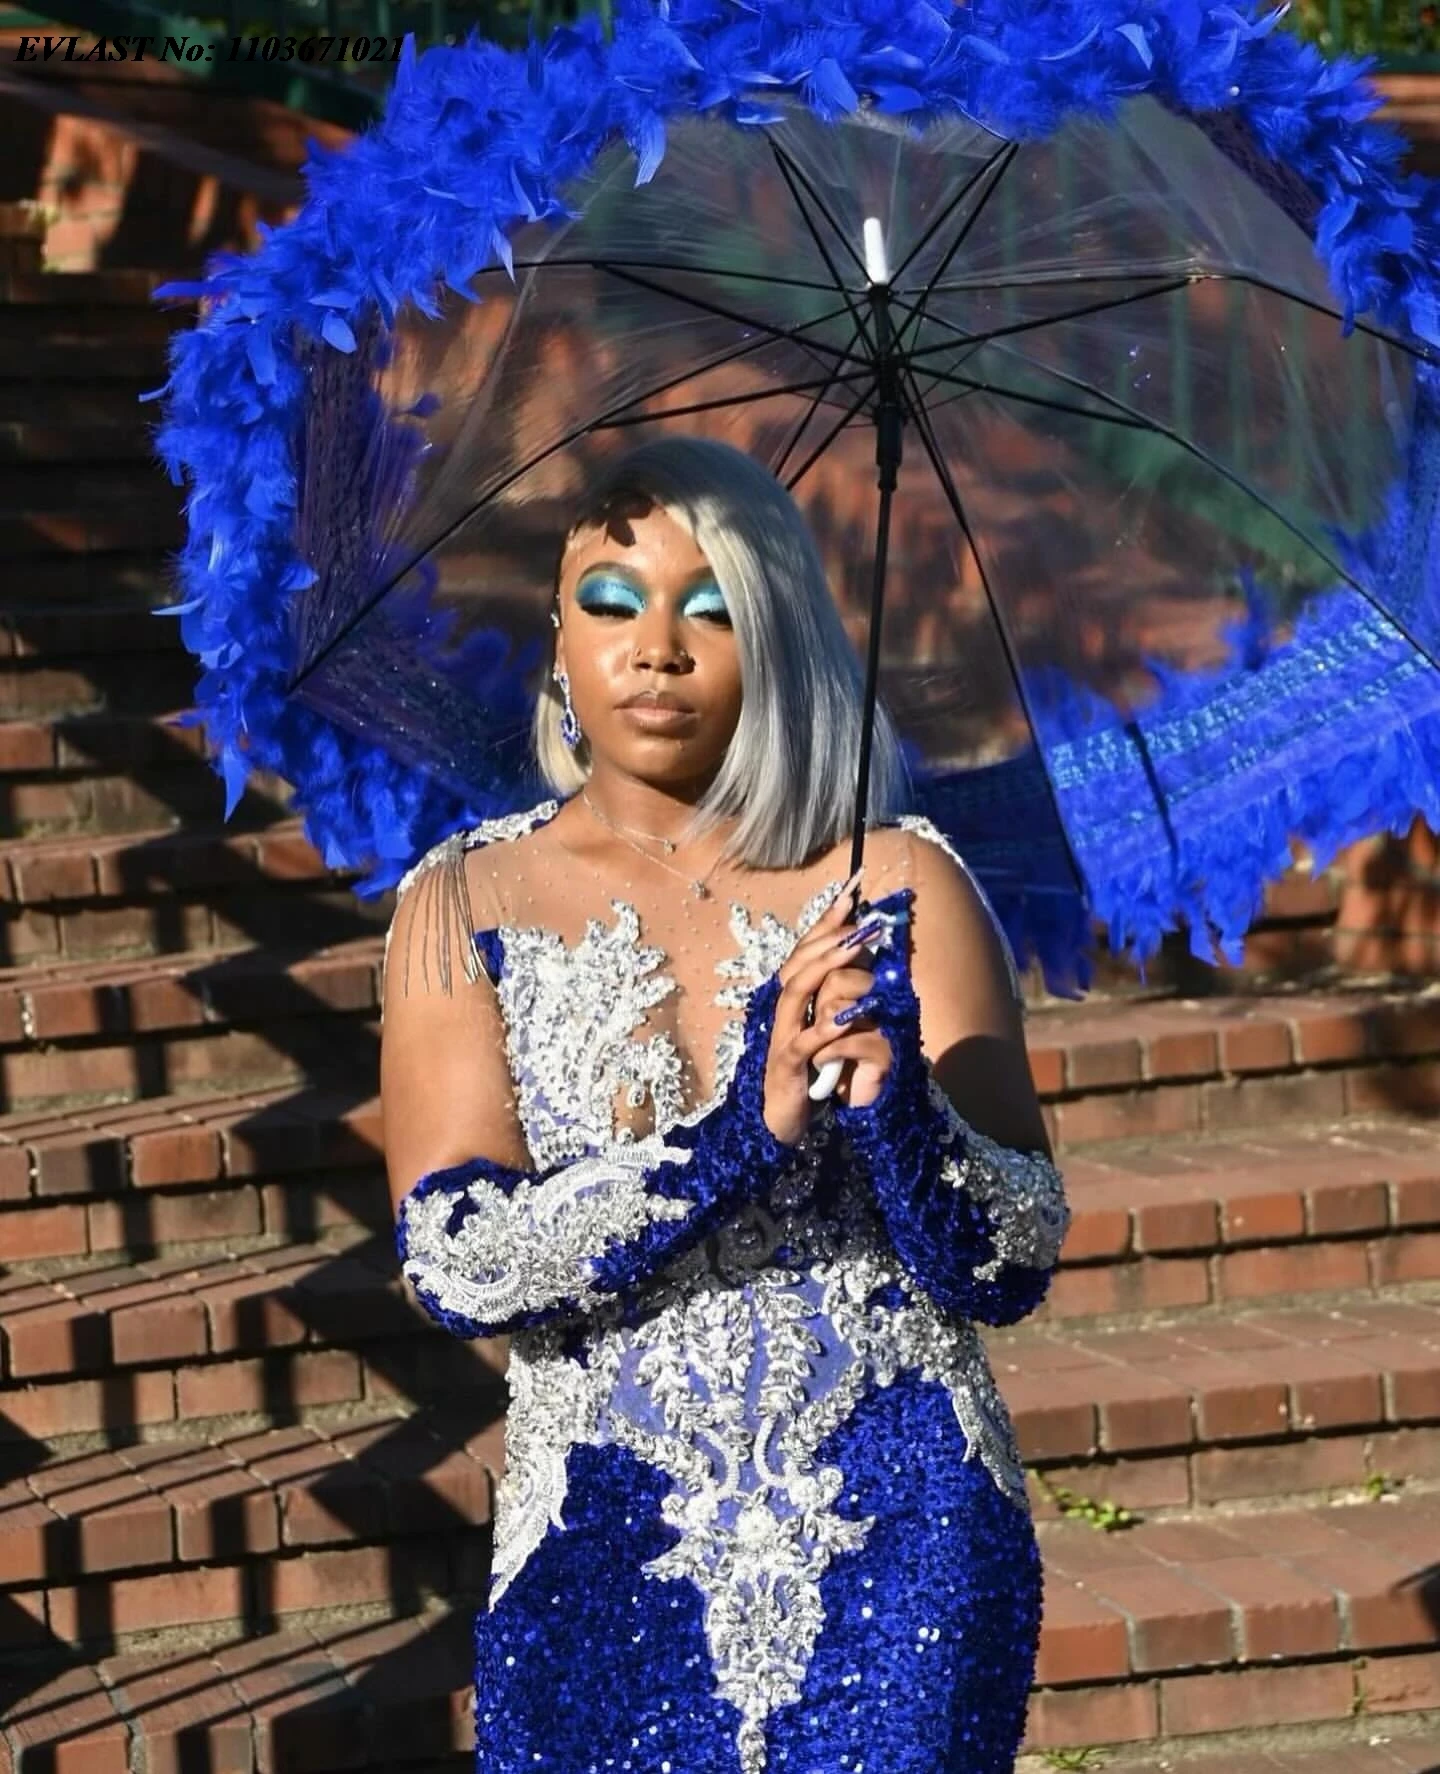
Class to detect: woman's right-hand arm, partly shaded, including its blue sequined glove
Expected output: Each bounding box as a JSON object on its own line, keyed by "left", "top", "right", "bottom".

{"left": 835, "top": 823, "right": 1069, "bottom": 1325}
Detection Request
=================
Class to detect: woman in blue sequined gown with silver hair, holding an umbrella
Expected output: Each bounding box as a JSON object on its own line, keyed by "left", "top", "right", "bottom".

{"left": 381, "top": 438, "right": 1068, "bottom": 1774}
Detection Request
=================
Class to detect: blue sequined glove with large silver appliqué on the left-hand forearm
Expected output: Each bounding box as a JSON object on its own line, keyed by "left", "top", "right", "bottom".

{"left": 395, "top": 976, "right": 798, "bottom": 1338}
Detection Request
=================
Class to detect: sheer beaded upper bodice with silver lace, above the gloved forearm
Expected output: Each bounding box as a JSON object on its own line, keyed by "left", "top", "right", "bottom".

{"left": 377, "top": 800, "right": 986, "bottom": 1162}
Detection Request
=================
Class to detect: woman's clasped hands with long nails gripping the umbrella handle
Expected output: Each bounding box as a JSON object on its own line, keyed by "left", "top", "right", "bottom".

{"left": 763, "top": 873, "right": 892, "bottom": 1146}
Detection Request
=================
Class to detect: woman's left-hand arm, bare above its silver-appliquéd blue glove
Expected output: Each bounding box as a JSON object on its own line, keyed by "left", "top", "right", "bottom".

{"left": 380, "top": 851, "right": 796, "bottom": 1338}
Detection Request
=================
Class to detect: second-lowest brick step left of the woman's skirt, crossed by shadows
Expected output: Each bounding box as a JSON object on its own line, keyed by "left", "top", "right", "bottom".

{"left": 0, "top": 1412, "right": 504, "bottom": 1624}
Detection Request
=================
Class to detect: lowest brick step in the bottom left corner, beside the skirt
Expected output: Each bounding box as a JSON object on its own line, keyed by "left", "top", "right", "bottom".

{"left": 0, "top": 1607, "right": 471, "bottom": 1774}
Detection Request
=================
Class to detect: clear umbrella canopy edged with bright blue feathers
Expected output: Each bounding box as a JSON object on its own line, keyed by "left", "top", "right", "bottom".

{"left": 148, "top": 4, "right": 1440, "bottom": 985}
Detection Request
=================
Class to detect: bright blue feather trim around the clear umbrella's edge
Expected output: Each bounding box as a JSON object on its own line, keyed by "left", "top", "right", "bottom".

{"left": 147, "top": 0, "right": 1440, "bottom": 979}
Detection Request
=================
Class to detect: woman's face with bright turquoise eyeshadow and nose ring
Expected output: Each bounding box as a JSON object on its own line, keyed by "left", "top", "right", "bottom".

{"left": 555, "top": 506, "right": 741, "bottom": 788}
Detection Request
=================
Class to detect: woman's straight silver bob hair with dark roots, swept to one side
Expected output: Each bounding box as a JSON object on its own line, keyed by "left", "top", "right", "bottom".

{"left": 534, "top": 436, "right": 910, "bottom": 869}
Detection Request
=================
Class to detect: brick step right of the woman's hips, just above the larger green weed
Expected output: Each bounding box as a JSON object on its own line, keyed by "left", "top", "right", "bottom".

{"left": 986, "top": 1286, "right": 1440, "bottom": 1515}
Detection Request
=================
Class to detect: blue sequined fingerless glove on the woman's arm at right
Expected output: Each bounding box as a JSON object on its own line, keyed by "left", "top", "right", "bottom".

{"left": 833, "top": 891, "right": 1069, "bottom": 1325}
